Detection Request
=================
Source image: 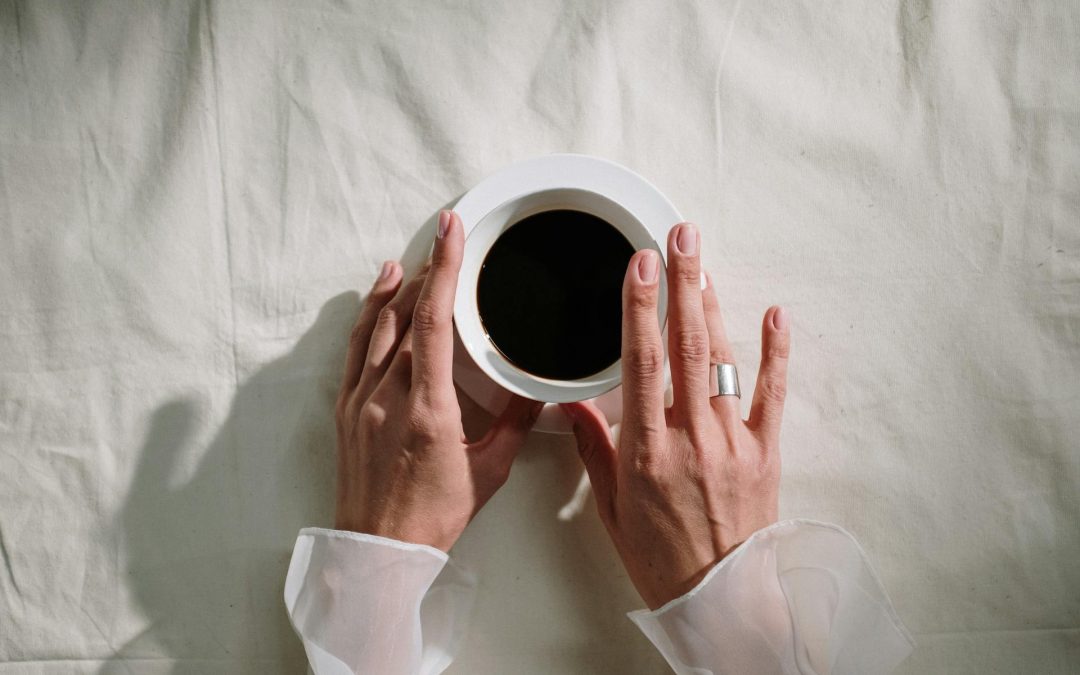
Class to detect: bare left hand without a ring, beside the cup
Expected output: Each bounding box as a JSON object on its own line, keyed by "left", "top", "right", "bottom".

{"left": 336, "top": 211, "right": 542, "bottom": 551}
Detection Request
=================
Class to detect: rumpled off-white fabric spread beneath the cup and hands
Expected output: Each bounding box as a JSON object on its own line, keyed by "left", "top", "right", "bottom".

{"left": 0, "top": 0, "right": 1080, "bottom": 674}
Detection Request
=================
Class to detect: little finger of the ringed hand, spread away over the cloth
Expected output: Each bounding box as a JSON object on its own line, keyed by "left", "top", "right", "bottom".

{"left": 747, "top": 307, "right": 792, "bottom": 447}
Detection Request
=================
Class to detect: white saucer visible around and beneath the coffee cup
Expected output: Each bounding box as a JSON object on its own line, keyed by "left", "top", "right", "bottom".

{"left": 454, "top": 154, "right": 683, "bottom": 433}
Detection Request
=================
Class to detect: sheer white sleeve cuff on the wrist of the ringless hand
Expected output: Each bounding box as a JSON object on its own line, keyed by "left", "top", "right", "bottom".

{"left": 285, "top": 528, "right": 476, "bottom": 675}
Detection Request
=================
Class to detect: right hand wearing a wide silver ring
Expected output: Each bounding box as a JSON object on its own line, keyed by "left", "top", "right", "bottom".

{"left": 563, "top": 224, "right": 789, "bottom": 609}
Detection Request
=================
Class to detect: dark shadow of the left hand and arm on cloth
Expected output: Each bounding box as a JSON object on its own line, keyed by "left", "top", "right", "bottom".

{"left": 102, "top": 293, "right": 360, "bottom": 673}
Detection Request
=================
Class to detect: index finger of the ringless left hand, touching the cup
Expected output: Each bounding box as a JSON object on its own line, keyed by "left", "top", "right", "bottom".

{"left": 413, "top": 211, "right": 465, "bottom": 400}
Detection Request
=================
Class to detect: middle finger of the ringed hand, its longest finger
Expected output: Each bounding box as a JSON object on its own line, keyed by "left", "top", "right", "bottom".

{"left": 667, "top": 222, "right": 708, "bottom": 423}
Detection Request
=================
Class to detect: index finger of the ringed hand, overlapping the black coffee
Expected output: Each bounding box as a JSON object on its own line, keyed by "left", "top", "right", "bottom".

{"left": 622, "top": 248, "right": 665, "bottom": 447}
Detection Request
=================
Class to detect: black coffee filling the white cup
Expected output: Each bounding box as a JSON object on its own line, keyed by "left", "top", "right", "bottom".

{"left": 476, "top": 210, "right": 634, "bottom": 380}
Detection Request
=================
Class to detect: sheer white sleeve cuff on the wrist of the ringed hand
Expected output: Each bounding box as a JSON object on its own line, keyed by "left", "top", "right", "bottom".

{"left": 630, "top": 521, "right": 914, "bottom": 675}
